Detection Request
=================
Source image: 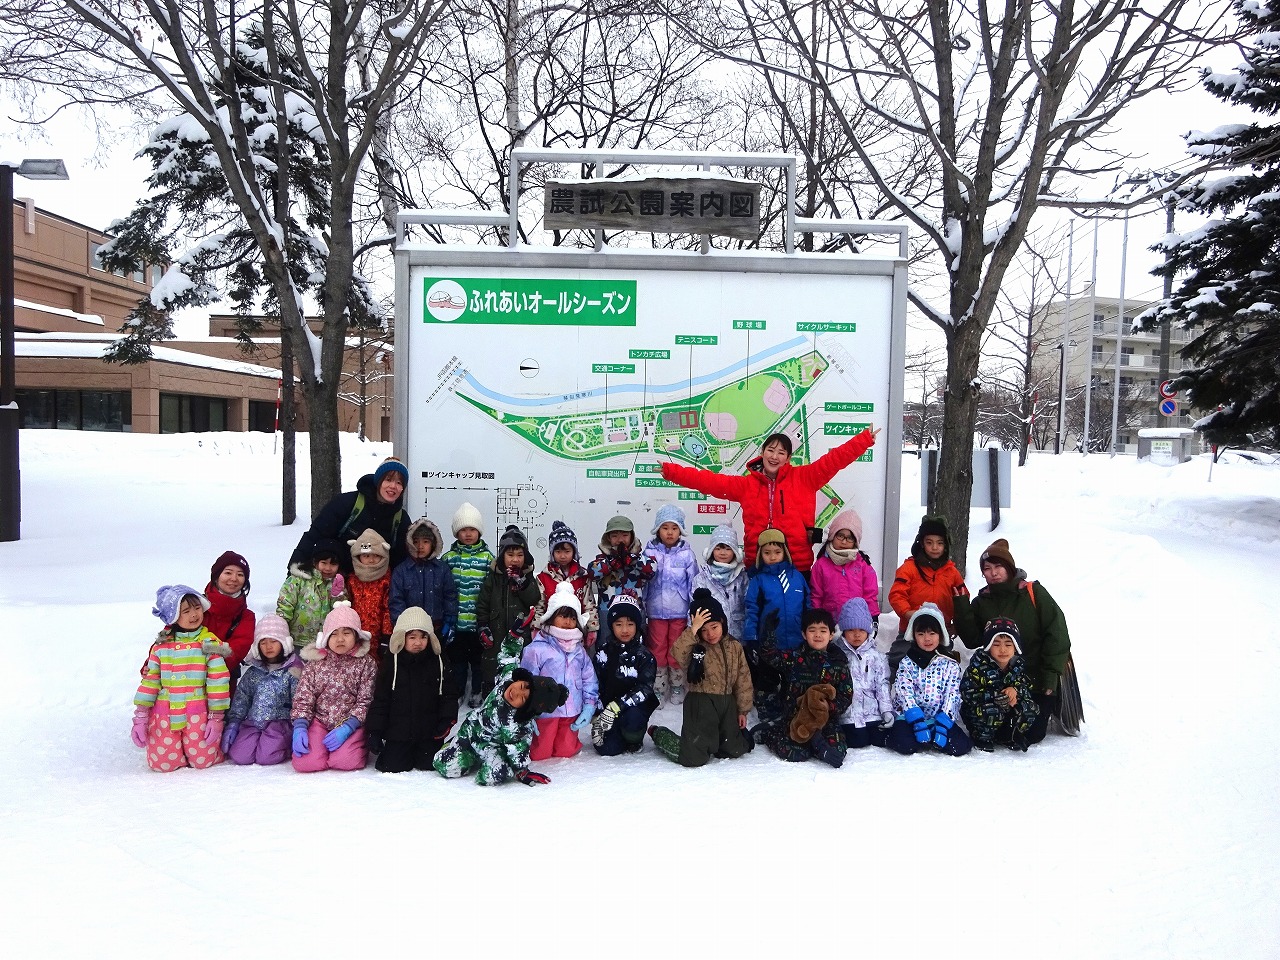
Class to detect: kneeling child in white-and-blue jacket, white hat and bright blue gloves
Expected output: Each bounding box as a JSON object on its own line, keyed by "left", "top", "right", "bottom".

{"left": 888, "top": 603, "right": 973, "bottom": 756}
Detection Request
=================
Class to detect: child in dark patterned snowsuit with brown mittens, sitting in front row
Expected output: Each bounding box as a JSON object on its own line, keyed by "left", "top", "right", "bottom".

{"left": 753, "top": 609, "right": 854, "bottom": 767}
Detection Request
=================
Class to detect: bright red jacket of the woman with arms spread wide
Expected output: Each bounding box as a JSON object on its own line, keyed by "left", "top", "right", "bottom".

{"left": 662, "top": 430, "right": 876, "bottom": 572}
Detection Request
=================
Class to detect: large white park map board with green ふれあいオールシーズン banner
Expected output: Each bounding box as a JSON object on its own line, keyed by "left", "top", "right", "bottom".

{"left": 397, "top": 256, "right": 901, "bottom": 566}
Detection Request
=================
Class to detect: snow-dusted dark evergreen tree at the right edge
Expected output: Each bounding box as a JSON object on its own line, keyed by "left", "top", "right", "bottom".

{"left": 1143, "top": 0, "right": 1280, "bottom": 447}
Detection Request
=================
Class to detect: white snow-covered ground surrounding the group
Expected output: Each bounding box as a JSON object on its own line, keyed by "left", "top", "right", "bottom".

{"left": 0, "top": 431, "right": 1280, "bottom": 960}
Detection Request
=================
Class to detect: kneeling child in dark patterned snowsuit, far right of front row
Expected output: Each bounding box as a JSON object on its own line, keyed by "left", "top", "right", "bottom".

{"left": 960, "top": 617, "right": 1039, "bottom": 753}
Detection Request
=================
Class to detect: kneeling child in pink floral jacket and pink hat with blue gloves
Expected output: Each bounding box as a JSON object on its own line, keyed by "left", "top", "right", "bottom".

{"left": 289, "top": 600, "right": 378, "bottom": 773}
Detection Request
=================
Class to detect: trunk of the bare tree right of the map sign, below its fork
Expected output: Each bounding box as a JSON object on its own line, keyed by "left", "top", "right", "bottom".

{"left": 937, "top": 321, "right": 982, "bottom": 572}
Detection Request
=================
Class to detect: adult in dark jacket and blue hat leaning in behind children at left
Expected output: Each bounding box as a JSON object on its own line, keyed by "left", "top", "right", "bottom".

{"left": 289, "top": 457, "right": 408, "bottom": 576}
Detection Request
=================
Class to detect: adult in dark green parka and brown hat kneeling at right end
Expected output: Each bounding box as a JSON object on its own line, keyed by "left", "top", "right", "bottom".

{"left": 955, "top": 540, "right": 1078, "bottom": 744}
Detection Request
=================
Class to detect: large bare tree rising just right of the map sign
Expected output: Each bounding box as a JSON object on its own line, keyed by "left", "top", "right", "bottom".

{"left": 672, "top": 0, "right": 1235, "bottom": 562}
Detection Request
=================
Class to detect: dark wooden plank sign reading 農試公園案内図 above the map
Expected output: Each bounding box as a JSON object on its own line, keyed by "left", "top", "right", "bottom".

{"left": 543, "top": 174, "right": 760, "bottom": 241}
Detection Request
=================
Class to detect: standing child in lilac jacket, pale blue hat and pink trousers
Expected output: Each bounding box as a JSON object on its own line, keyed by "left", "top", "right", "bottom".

{"left": 644, "top": 503, "right": 698, "bottom": 704}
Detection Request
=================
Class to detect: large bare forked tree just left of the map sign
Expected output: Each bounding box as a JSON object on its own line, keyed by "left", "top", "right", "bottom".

{"left": 6, "top": 0, "right": 445, "bottom": 511}
